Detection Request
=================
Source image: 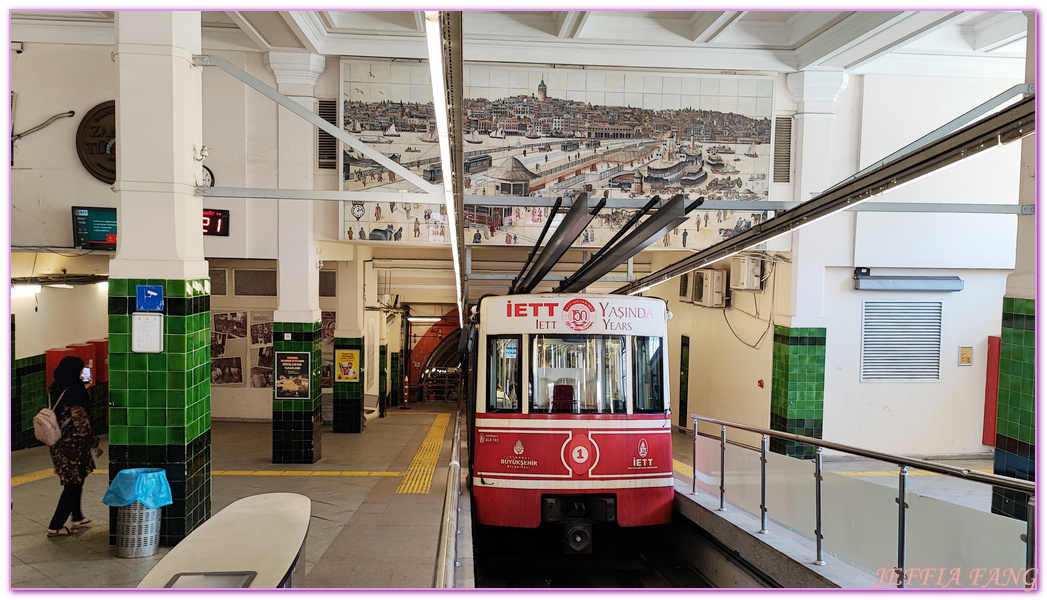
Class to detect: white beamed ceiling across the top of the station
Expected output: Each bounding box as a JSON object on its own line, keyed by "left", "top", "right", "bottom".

{"left": 10, "top": 10, "right": 1027, "bottom": 76}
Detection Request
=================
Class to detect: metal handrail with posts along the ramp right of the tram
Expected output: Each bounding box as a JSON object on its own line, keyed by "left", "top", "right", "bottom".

{"left": 690, "top": 415, "right": 1035, "bottom": 587}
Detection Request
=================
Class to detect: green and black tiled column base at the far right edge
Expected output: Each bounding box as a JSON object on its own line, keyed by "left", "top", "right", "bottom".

{"left": 993, "top": 297, "right": 1037, "bottom": 520}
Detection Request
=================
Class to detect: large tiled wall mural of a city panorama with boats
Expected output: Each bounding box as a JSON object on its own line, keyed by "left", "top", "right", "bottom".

{"left": 340, "top": 60, "right": 774, "bottom": 248}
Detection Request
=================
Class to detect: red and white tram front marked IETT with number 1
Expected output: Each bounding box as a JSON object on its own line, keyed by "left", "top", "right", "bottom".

{"left": 472, "top": 294, "right": 673, "bottom": 528}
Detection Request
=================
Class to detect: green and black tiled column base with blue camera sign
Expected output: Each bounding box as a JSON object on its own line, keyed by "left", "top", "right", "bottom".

{"left": 109, "top": 279, "right": 210, "bottom": 546}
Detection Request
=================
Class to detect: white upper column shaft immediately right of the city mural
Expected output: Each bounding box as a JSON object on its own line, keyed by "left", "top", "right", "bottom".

{"left": 781, "top": 71, "right": 847, "bottom": 327}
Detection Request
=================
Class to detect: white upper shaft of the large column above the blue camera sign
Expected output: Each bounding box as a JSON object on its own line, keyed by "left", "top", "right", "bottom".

{"left": 109, "top": 10, "right": 207, "bottom": 280}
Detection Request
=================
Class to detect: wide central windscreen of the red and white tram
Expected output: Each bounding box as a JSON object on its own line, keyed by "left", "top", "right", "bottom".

{"left": 531, "top": 335, "right": 625, "bottom": 414}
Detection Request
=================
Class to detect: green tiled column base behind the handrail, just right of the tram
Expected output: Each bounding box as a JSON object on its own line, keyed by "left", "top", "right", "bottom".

{"left": 770, "top": 325, "right": 825, "bottom": 459}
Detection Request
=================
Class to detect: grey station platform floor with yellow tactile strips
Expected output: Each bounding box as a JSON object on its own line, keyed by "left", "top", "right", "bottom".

{"left": 10, "top": 402, "right": 992, "bottom": 590}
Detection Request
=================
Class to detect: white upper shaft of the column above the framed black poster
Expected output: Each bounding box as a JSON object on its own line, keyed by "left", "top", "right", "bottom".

{"left": 266, "top": 51, "right": 326, "bottom": 323}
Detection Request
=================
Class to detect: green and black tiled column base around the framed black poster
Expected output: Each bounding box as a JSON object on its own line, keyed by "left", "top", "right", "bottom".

{"left": 272, "top": 321, "right": 322, "bottom": 464}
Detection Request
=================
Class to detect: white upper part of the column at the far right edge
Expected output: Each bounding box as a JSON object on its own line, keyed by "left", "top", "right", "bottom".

{"left": 1004, "top": 12, "right": 1037, "bottom": 299}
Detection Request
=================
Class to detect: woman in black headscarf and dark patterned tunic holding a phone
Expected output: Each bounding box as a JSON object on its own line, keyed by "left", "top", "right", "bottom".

{"left": 47, "top": 356, "right": 102, "bottom": 537}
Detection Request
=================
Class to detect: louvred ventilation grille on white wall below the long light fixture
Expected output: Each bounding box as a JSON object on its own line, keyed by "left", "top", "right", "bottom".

{"left": 862, "top": 302, "right": 941, "bottom": 381}
